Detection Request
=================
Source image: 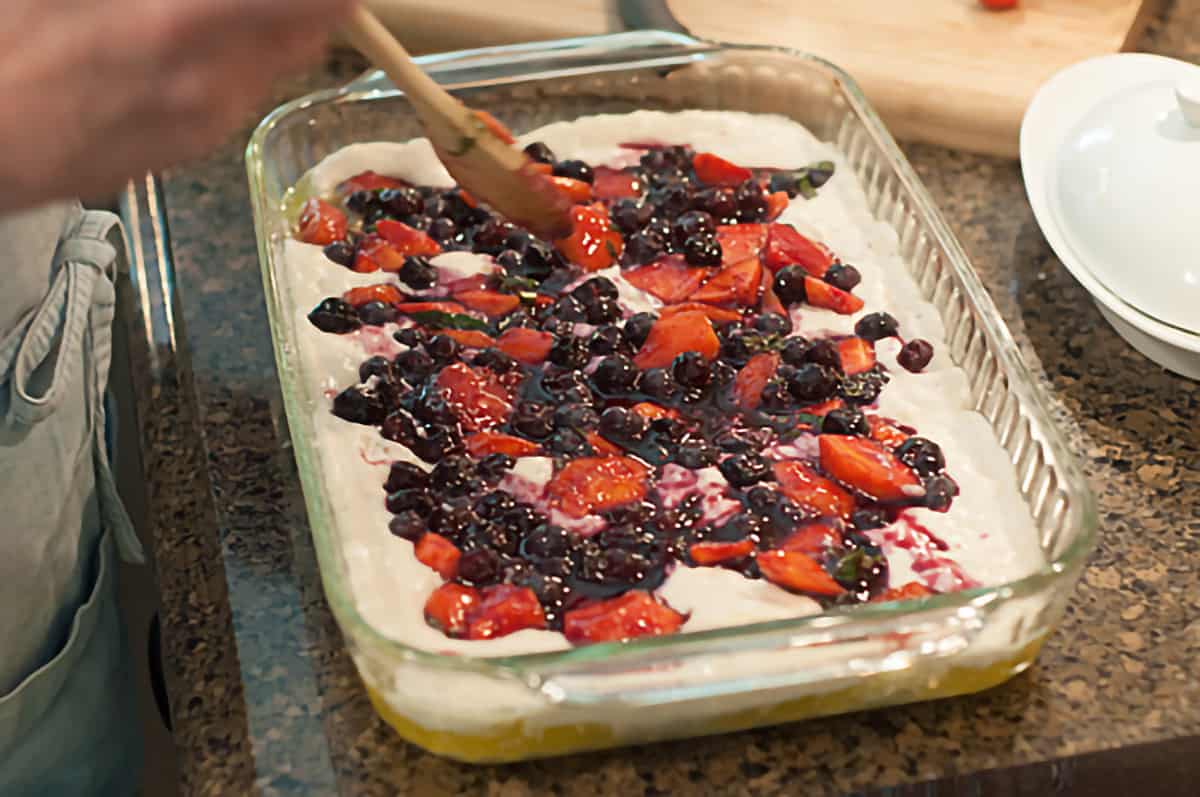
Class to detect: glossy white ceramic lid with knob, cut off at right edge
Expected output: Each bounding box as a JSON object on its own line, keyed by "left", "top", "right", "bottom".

{"left": 1021, "top": 54, "right": 1200, "bottom": 334}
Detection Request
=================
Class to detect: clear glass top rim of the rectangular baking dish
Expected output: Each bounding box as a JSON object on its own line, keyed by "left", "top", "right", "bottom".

{"left": 246, "top": 31, "right": 1098, "bottom": 678}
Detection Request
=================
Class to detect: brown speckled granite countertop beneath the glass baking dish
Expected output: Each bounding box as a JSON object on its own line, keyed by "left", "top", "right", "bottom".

{"left": 143, "top": 0, "right": 1200, "bottom": 797}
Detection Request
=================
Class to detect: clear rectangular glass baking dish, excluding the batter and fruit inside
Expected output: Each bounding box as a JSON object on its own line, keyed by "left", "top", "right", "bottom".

{"left": 247, "top": 31, "right": 1097, "bottom": 762}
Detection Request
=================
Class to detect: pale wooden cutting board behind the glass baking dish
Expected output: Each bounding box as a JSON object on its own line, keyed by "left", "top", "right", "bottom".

{"left": 371, "top": 0, "right": 1160, "bottom": 157}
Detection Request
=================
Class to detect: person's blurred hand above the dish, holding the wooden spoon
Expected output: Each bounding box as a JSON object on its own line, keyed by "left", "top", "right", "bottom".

{"left": 0, "top": 0, "right": 354, "bottom": 211}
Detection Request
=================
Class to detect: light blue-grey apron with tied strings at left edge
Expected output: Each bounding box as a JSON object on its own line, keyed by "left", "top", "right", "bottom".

{"left": 0, "top": 206, "right": 142, "bottom": 797}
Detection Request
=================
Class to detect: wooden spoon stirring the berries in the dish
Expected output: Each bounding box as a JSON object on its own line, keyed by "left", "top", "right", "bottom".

{"left": 346, "top": 5, "right": 571, "bottom": 240}
